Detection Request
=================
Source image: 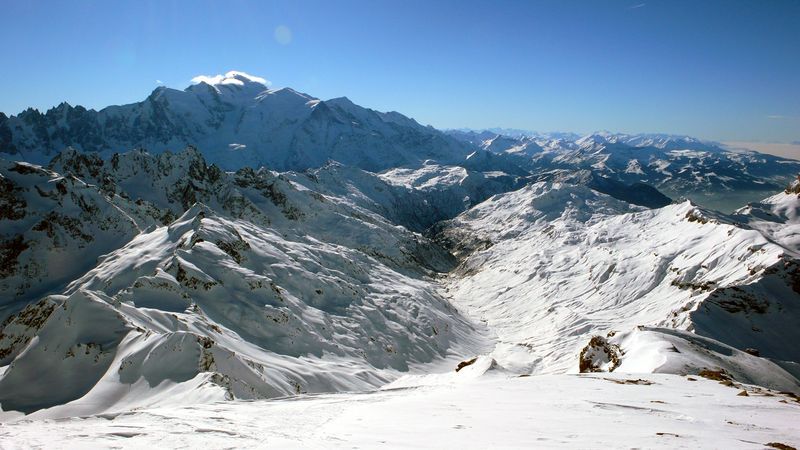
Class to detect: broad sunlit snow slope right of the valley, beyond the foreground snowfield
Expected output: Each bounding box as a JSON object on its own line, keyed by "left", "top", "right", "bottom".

{"left": 442, "top": 183, "right": 800, "bottom": 392}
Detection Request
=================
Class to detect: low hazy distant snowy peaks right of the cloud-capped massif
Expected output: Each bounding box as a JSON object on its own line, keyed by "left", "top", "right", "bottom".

{"left": 448, "top": 127, "right": 800, "bottom": 211}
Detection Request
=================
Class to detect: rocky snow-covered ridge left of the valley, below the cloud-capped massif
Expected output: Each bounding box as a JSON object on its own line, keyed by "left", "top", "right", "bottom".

{"left": 0, "top": 149, "right": 487, "bottom": 417}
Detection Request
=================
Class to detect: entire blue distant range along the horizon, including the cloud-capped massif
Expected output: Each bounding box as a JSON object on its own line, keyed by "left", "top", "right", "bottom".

{"left": 0, "top": 72, "right": 800, "bottom": 211}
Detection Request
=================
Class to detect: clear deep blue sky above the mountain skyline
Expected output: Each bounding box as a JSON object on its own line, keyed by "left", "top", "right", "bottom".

{"left": 0, "top": 0, "right": 800, "bottom": 142}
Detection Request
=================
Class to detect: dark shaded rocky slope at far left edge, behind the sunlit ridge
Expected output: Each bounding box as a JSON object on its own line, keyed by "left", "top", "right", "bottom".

{"left": 0, "top": 160, "right": 139, "bottom": 321}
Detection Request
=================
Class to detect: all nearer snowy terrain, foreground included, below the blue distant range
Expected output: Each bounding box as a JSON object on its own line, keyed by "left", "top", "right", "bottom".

{"left": 0, "top": 148, "right": 800, "bottom": 448}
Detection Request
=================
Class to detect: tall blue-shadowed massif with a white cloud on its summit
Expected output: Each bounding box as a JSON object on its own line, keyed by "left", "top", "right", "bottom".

{"left": 0, "top": 72, "right": 475, "bottom": 171}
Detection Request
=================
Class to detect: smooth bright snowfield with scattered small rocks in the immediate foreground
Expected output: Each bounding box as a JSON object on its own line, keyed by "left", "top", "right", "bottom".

{"left": 0, "top": 368, "right": 800, "bottom": 449}
